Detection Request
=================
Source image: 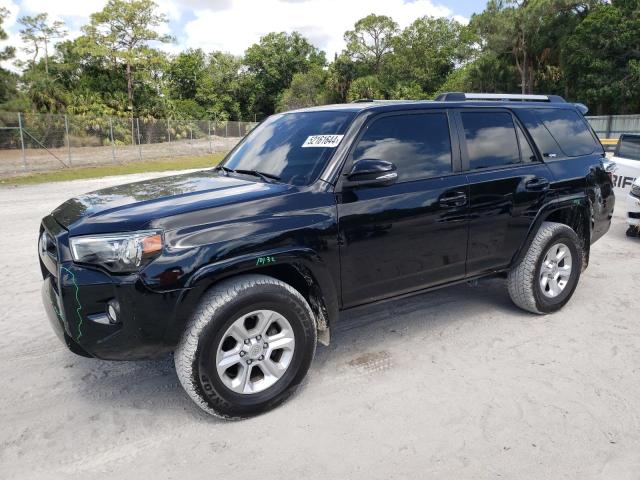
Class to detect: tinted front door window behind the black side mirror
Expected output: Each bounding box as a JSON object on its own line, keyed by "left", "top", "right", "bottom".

{"left": 353, "top": 113, "right": 451, "bottom": 181}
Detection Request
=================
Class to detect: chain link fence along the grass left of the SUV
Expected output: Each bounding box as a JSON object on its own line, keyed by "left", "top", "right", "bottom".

{"left": 0, "top": 112, "right": 256, "bottom": 176}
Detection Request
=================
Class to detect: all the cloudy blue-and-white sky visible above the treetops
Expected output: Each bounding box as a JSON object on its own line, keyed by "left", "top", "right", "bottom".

{"left": 0, "top": 0, "right": 486, "bottom": 70}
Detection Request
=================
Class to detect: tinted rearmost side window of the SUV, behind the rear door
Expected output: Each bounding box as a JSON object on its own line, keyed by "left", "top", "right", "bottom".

{"left": 536, "top": 108, "right": 598, "bottom": 157}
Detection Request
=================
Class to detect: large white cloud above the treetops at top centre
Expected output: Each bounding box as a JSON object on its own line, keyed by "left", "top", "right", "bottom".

{"left": 180, "top": 0, "right": 460, "bottom": 58}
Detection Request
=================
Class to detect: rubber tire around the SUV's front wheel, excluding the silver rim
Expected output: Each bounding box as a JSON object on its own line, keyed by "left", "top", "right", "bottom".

{"left": 174, "top": 274, "right": 317, "bottom": 419}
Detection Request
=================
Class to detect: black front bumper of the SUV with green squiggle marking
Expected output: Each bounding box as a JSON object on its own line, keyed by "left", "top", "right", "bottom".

{"left": 39, "top": 217, "right": 182, "bottom": 360}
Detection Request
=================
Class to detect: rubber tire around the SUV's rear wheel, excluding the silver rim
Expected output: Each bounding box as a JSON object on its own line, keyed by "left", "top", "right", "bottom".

{"left": 507, "top": 222, "right": 584, "bottom": 314}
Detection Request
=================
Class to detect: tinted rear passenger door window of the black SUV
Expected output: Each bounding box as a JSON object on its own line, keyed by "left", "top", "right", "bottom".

{"left": 461, "top": 112, "right": 520, "bottom": 170}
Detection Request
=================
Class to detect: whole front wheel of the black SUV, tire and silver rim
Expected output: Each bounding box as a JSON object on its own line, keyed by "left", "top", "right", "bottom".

{"left": 175, "top": 275, "right": 316, "bottom": 418}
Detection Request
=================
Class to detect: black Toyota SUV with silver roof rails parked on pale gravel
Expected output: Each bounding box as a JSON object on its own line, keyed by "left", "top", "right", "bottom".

{"left": 39, "top": 93, "right": 614, "bottom": 417}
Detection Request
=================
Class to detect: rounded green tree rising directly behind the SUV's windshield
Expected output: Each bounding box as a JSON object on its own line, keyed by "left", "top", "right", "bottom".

{"left": 244, "top": 32, "right": 326, "bottom": 115}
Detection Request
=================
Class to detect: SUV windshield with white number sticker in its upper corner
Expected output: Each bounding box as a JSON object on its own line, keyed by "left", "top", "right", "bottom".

{"left": 223, "top": 111, "right": 355, "bottom": 185}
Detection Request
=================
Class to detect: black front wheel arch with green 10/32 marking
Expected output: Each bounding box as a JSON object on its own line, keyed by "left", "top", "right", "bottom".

{"left": 166, "top": 248, "right": 339, "bottom": 345}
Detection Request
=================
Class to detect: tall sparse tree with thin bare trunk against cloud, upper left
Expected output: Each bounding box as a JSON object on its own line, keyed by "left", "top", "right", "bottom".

{"left": 83, "top": 0, "right": 172, "bottom": 114}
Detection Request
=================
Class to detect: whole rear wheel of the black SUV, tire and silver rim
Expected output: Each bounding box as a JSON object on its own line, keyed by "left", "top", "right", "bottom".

{"left": 507, "top": 222, "right": 584, "bottom": 314}
